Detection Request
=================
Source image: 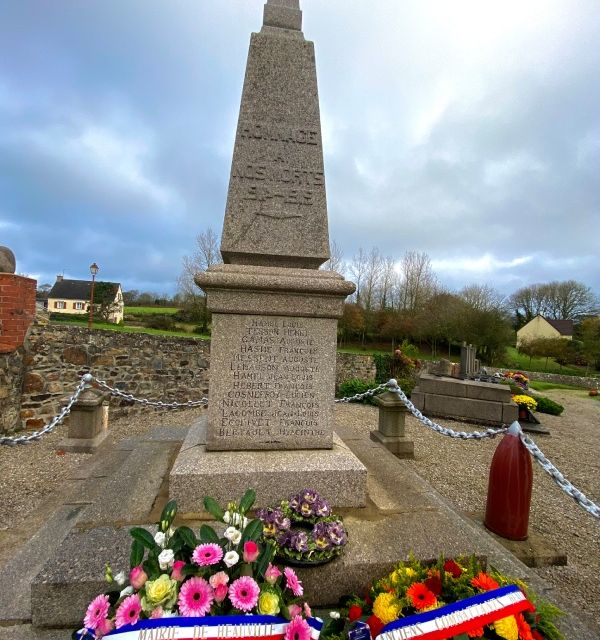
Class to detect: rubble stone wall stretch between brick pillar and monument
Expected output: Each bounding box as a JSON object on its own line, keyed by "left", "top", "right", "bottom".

{"left": 20, "top": 320, "right": 209, "bottom": 429}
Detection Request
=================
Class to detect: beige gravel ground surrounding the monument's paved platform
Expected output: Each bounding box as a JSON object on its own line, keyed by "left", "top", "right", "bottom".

{"left": 0, "top": 390, "right": 600, "bottom": 620}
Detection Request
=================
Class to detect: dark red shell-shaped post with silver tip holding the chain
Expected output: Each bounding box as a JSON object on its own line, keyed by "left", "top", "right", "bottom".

{"left": 484, "top": 422, "right": 533, "bottom": 540}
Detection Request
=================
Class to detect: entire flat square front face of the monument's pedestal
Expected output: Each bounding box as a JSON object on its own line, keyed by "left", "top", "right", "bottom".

{"left": 206, "top": 313, "right": 337, "bottom": 450}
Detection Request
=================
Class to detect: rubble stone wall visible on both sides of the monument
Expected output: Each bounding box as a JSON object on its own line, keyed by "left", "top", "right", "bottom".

{"left": 0, "top": 322, "right": 394, "bottom": 433}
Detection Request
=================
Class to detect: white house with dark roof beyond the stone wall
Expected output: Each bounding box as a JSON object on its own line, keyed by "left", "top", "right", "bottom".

{"left": 48, "top": 276, "right": 124, "bottom": 324}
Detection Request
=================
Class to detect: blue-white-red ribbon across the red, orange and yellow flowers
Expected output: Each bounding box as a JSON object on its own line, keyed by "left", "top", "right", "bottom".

{"left": 377, "top": 585, "right": 534, "bottom": 640}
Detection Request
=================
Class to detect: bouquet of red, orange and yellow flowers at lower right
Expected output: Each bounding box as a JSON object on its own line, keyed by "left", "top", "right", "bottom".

{"left": 321, "top": 556, "right": 564, "bottom": 640}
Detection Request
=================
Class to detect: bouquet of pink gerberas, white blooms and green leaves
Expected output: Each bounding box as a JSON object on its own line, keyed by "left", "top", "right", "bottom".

{"left": 73, "top": 489, "right": 311, "bottom": 640}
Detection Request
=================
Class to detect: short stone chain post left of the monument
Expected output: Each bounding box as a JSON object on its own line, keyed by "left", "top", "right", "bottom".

{"left": 57, "top": 387, "right": 108, "bottom": 453}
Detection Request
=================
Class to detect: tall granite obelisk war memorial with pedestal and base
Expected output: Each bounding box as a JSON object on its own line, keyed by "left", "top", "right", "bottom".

{"left": 170, "top": 0, "right": 366, "bottom": 511}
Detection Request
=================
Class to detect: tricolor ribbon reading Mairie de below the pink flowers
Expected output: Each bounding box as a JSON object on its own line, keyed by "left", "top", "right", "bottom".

{"left": 78, "top": 615, "right": 323, "bottom": 640}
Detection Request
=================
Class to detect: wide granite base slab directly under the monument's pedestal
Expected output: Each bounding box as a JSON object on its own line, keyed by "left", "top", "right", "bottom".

{"left": 169, "top": 416, "right": 367, "bottom": 514}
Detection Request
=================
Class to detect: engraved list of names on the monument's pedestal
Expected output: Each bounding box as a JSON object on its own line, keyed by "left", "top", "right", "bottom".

{"left": 216, "top": 316, "right": 325, "bottom": 441}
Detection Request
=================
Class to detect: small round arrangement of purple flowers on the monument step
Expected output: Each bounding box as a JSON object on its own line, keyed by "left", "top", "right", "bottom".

{"left": 256, "top": 489, "right": 348, "bottom": 564}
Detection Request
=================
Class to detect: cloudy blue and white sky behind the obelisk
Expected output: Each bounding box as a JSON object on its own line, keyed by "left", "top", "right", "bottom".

{"left": 0, "top": 0, "right": 600, "bottom": 293}
